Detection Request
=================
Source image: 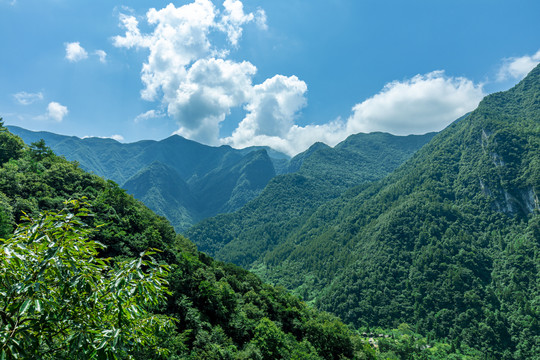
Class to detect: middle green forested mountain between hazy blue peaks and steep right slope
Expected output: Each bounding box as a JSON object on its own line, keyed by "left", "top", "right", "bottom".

{"left": 186, "top": 133, "right": 435, "bottom": 268}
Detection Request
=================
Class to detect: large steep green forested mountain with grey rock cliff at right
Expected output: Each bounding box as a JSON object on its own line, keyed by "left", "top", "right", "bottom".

{"left": 192, "top": 65, "right": 540, "bottom": 359}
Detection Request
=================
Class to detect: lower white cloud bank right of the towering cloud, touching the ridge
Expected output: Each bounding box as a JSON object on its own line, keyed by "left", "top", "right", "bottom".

{"left": 223, "top": 71, "right": 485, "bottom": 156}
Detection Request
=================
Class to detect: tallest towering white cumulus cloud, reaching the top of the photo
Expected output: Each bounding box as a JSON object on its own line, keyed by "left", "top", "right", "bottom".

{"left": 113, "top": 0, "right": 266, "bottom": 144}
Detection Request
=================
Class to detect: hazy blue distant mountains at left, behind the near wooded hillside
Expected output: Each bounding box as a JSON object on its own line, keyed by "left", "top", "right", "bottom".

{"left": 8, "top": 126, "right": 282, "bottom": 231}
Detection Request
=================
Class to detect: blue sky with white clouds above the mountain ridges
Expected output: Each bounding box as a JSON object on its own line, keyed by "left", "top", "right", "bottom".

{"left": 0, "top": 0, "right": 540, "bottom": 155}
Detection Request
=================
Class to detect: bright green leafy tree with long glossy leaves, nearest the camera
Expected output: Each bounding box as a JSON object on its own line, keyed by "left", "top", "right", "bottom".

{"left": 0, "top": 201, "right": 173, "bottom": 359}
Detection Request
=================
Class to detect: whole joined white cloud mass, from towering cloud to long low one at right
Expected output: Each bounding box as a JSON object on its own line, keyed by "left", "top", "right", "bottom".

{"left": 113, "top": 0, "right": 484, "bottom": 155}
